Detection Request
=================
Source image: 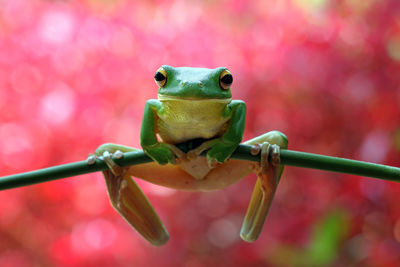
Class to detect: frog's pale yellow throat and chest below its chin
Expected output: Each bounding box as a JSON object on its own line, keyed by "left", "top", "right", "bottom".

{"left": 157, "top": 99, "right": 230, "bottom": 144}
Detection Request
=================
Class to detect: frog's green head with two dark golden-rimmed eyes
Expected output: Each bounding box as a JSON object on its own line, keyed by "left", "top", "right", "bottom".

{"left": 154, "top": 65, "right": 233, "bottom": 100}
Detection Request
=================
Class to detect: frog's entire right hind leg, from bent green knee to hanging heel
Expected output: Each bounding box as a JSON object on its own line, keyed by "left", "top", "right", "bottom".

{"left": 240, "top": 131, "right": 288, "bottom": 242}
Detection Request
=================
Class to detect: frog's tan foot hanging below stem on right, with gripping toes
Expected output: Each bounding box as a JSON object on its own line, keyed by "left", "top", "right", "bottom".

{"left": 240, "top": 142, "right": 281, "bottom": 242}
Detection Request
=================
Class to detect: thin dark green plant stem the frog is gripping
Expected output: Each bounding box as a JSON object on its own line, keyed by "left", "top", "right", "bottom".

{"left": 0, "top": 144, "right": 400, "bottom": 190}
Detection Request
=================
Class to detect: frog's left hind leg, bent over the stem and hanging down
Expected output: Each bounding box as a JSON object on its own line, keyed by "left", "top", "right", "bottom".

{"left": 89, "top": 144, "right": 169, "bottom": 246}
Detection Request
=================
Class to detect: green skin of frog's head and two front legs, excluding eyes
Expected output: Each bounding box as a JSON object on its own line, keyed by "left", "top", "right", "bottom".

{"left": 140, "top": 65, "right": 246, "bottom": 164}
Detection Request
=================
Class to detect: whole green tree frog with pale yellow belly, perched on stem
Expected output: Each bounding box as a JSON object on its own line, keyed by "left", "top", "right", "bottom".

{"left": 91, "top": 65, "right": 288, "bottom": 246}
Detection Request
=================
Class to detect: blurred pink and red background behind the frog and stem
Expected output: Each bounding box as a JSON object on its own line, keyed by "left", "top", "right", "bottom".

{"left": 0, "top": 0, "right": 400, "bottom": 267}
